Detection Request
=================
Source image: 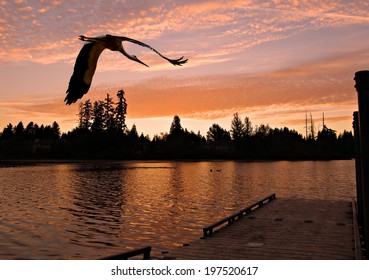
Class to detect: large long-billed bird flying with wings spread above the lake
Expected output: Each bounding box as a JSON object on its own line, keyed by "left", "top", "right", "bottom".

{"left": 64, "top": 34, "right": 187, "bottom": 105}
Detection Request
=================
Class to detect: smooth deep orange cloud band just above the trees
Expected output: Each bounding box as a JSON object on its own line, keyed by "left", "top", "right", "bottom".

{"left": 82, "top": 60, "right": 355, "bottom": 122}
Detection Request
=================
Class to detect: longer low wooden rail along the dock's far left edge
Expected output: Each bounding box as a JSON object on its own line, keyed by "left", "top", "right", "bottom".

{"left": 202, "top": 193, "right": 275, "bottom": 237}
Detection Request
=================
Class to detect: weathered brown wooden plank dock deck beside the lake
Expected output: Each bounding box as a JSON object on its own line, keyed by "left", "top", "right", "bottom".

{"left": 152, "top": 198, "right": 357, "bottom": 260}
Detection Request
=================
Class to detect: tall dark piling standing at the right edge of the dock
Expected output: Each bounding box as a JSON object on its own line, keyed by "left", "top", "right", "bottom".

{"left": 353, "top": 70, "right": 369, "bottom": 259}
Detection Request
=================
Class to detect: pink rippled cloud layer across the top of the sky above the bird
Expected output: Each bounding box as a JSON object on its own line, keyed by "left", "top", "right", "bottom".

{"left": 0, "top": 0, "right": 368, "bottom": 67}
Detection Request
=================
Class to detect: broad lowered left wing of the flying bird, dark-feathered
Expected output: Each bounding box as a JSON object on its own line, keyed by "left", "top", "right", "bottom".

{"left": 64, "top": 43, "right": 105, "bottom": 105}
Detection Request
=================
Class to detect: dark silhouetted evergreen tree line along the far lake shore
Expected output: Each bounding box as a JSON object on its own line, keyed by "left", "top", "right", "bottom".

{"left": 0, "top": 110, "right": 354, "bottom": 160}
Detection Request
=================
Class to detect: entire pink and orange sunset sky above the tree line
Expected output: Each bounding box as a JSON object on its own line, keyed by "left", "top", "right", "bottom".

{"left": 0, "top": 0, "right": 369, "bottom": 136}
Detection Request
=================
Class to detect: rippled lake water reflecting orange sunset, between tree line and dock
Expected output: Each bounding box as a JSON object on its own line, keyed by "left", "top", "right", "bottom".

{"left": 0, "top": 160, "right": 356, "bottom": 259}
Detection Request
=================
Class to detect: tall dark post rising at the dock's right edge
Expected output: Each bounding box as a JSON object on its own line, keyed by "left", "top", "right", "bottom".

{"left": 355, "top": 70, "right": 369, "bottom": 258}
